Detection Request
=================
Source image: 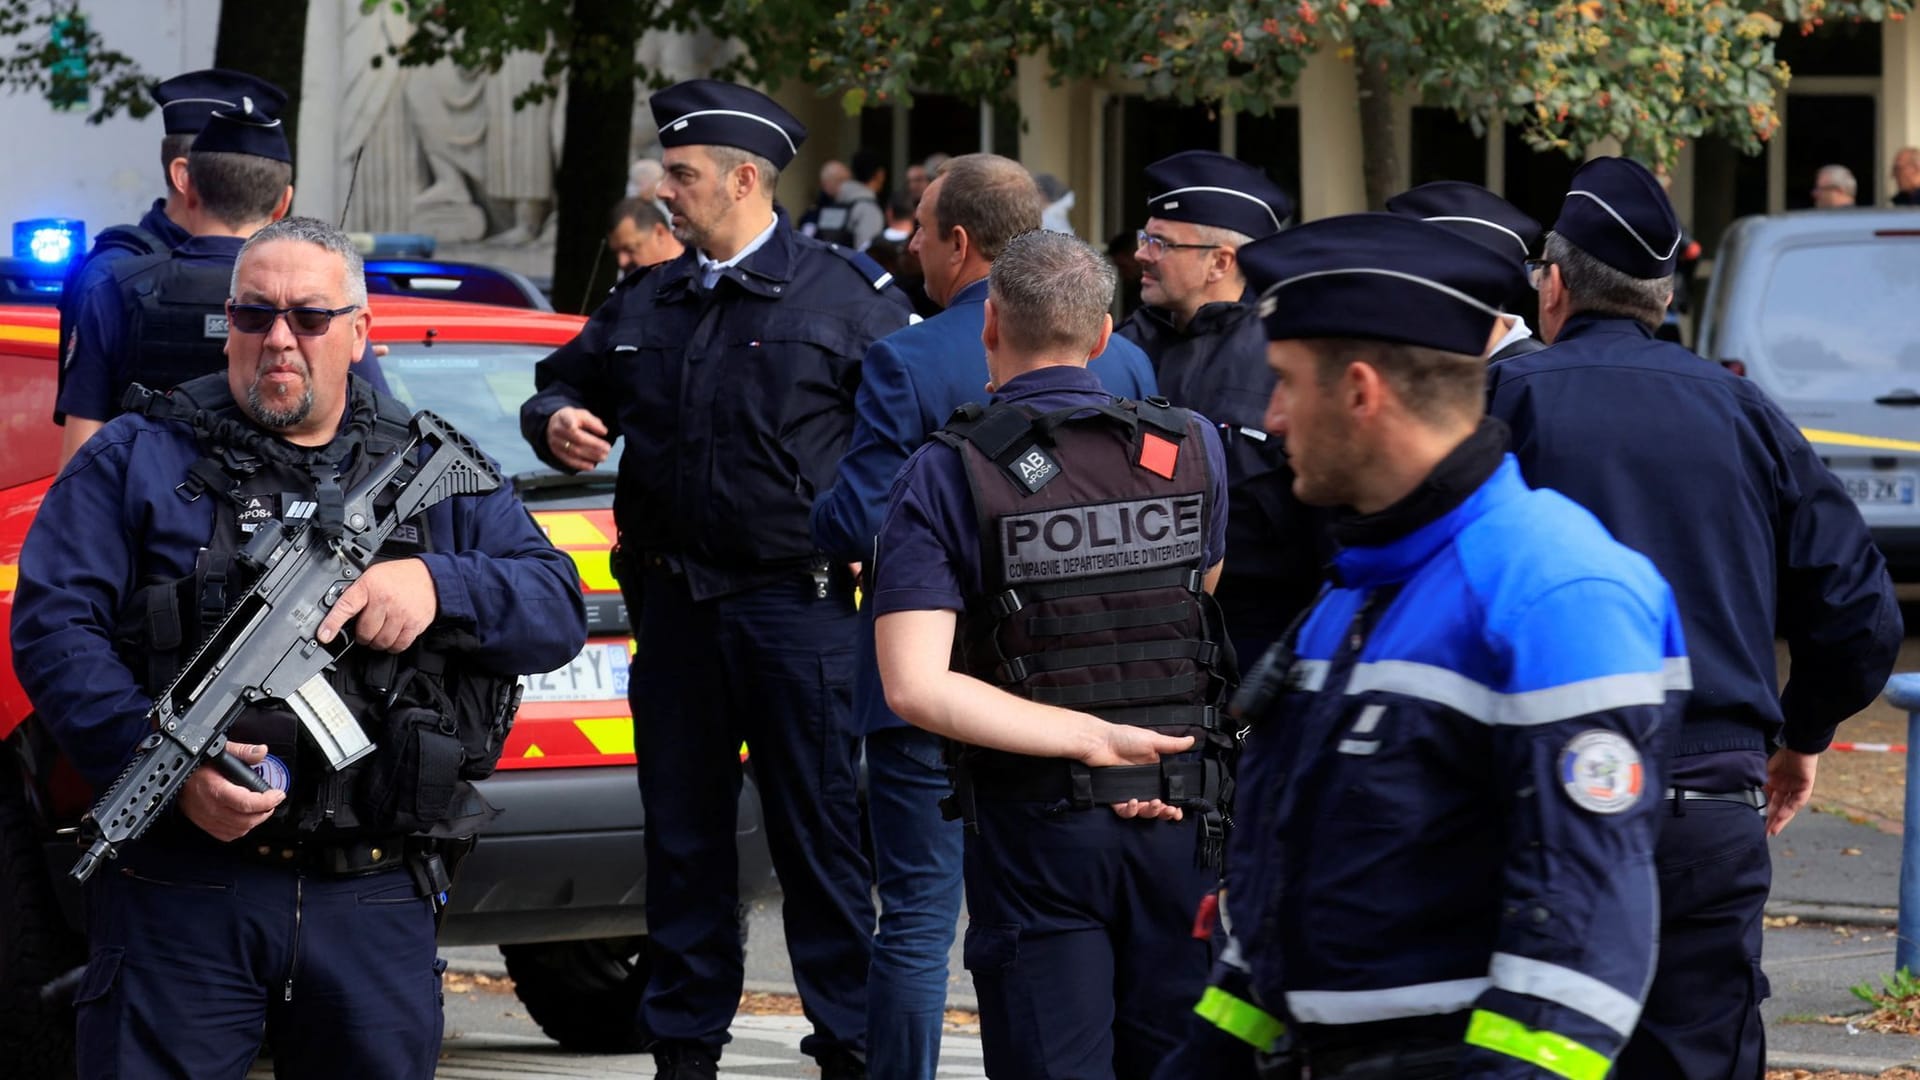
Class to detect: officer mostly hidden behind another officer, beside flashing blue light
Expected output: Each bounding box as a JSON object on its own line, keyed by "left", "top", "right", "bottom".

{"left": 54, "top": 67, "right": 286, "bottom": 386}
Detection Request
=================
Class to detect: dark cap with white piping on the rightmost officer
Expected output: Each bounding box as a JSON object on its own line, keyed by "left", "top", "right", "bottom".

{"left": 1553, "top": 158, "right": 1680, "bottom": 281}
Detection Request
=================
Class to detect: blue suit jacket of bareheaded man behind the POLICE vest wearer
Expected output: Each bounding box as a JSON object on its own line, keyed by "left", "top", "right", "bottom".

{"left": 812, "top": 279, "right": 1154, "bottom": 734}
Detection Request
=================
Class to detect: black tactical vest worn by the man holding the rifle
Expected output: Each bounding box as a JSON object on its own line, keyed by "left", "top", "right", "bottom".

{"left": 115, "top": 373, "right": 518, "bottom": 838}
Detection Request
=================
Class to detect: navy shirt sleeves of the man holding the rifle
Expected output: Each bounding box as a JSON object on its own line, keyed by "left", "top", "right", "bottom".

{"left": 13, "top": 390, "right": 586, "bottom": 786}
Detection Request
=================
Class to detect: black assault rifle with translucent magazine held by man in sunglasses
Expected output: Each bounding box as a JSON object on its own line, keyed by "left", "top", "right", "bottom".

{"left": 71, "top": 411, "right": 501, "bottom": 882}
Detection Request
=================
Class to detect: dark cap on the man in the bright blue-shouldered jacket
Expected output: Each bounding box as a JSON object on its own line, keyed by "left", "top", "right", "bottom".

{"left": 1240, "top": 213, "right": 1513, "bottom": 356}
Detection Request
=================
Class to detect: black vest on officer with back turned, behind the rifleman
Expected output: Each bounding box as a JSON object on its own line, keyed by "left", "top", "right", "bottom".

{"left": 113, "top": 252, "right": 234, "bottom": 413}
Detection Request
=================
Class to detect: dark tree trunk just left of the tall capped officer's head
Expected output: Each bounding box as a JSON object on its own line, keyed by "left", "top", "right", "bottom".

{"left": 553, "top": 0, "right": 639, "bottom": 313}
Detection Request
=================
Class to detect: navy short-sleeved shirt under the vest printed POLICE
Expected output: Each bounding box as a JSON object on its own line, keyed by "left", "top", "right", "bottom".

{"left": 868, "top": 365, "right": 1227, "bottom": 617}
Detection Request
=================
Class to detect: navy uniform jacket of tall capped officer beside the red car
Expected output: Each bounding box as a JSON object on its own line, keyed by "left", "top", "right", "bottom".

{"left": 520, "top": 213, "right": 910, "bottom": 600}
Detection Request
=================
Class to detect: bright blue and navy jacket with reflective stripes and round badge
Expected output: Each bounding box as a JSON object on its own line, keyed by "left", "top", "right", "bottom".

{"left": 1200, "top": 423, "right": 1690, "bottom": 1080}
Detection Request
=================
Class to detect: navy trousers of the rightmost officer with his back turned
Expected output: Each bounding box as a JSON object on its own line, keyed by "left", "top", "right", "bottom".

{"left": 1613, "top": 799, "right": 1774, "bottom": 1080}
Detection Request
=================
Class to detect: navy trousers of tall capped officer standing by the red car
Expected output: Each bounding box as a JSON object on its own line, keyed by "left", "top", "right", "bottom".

{"left": 630, "top": 571, "right": 874, "bottom": 1059}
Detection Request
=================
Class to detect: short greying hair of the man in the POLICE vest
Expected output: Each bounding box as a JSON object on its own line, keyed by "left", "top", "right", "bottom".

{"left": 987, "top": 229, "right": 1119, "bottom": 354}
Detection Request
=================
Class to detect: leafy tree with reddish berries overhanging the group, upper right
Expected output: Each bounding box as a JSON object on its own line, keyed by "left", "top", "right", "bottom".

{"left": 810, "top": 0, "right": 1908, "bottom": 208}
